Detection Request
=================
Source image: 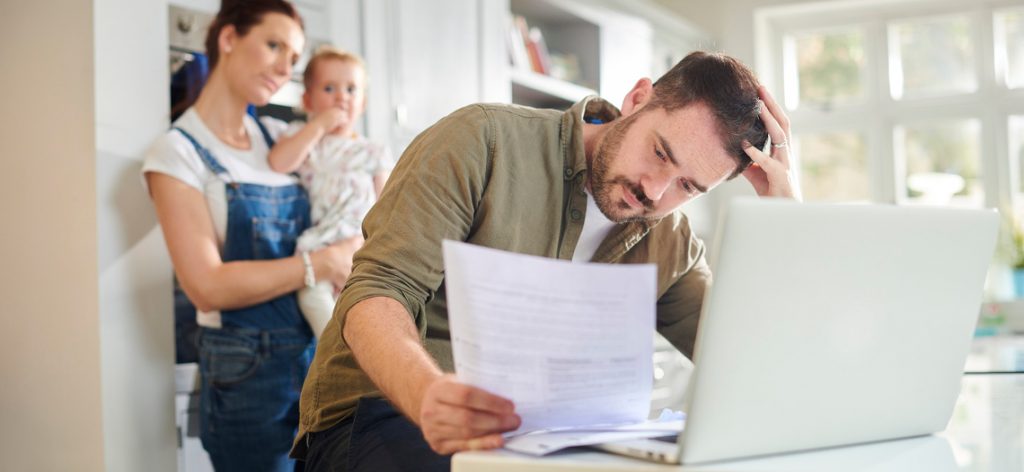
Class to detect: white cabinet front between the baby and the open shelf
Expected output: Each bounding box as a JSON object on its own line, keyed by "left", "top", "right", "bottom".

{"left": 364, "top": 0, "right": 504, "bottom": 153}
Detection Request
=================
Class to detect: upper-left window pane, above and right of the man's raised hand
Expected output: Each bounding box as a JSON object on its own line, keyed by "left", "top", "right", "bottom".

{"left": 786, "top": 30, "right": 864, "bottom": 110}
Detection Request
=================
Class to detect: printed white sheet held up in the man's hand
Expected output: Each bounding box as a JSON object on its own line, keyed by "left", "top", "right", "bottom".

{"left": 443, "top": 241, "right": 656, "bottom": 437}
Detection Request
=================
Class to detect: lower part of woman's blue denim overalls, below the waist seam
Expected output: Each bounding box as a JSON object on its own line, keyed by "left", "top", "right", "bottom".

{"left": 199, "top": 327, "right": 315, "bottom": 472}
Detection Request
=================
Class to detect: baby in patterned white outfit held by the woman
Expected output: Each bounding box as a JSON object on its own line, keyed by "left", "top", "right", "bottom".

{"left": 268, "top": 47, "right": 394, "bottom": 339}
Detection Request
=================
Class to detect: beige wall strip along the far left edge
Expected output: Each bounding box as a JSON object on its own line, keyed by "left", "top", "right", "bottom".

{"left": 0, "top": 0, "right": 103, "bottom": 471}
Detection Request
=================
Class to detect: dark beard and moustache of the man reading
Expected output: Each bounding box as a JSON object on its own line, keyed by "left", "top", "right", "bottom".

{"left": 590, "top": 114, "right": 656, "bottom": 223}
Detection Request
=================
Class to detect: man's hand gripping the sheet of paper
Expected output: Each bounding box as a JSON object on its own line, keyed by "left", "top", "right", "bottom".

{"left": 417, "top": 374, "right": 521, "bottom": 455}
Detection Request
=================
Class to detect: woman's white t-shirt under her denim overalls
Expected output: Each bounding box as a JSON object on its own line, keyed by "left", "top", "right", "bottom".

{"left": 142, "top": 109, "right": 298, "bottom": 328}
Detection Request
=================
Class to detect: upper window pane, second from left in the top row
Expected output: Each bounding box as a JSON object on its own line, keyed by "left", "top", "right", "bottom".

{"left": 889, "top": 15, "right": 978, "bottom": 99}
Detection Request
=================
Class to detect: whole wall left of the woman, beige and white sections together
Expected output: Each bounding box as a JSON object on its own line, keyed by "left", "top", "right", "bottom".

{"left": 0, "top": 0, "right": 176, "bottom": 471}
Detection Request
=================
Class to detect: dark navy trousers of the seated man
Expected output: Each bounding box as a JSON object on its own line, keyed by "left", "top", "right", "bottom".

{"left": 305, "top": 397, "right": 452, "bottom": 472}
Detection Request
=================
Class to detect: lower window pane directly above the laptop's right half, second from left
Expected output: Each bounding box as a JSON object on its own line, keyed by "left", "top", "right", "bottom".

{"left": 895, "top": 119, "right": 985, "bottom": 207}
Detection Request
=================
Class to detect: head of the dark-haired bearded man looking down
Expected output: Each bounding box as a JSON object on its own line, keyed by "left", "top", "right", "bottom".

{"left": 590, "top": 52, "right": 768, "bottom": 222}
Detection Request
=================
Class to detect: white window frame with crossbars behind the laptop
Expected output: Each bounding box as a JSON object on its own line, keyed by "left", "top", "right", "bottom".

{"left": 754, "top": 0, "right": 1024, "bottom": 208}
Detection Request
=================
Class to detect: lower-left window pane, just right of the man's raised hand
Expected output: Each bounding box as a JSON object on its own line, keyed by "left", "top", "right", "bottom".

{"left": 795, "top": 132, "right": 871, "bottom": 202}
